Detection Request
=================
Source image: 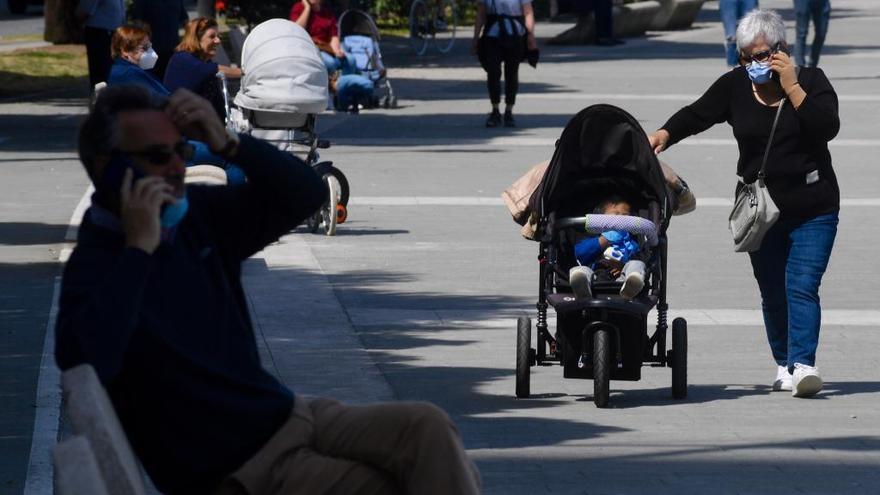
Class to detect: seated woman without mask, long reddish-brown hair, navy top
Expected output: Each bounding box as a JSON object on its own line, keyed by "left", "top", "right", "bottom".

{"left": 165, "top": 17, "right": 242, "bottom": 119}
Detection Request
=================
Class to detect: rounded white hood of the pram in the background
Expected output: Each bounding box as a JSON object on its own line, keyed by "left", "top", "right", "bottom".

{"left": 235, "top": 19, "right": 328, "bottom": 114}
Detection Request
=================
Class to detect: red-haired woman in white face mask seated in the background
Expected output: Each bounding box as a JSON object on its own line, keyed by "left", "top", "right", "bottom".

{"left": 107, "top": 25, "right": 171, "bottom": 96}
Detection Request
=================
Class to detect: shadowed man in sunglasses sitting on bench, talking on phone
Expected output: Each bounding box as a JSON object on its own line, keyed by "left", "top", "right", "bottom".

{"left": 55, "top": 86, "right": 479, "bottom": 495}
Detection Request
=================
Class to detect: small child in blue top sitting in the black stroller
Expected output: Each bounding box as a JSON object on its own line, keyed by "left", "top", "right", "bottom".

{"left": 568, "top": 196, "right": 645, "bottom": 299}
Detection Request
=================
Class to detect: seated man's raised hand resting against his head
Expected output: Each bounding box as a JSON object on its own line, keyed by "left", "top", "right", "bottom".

{"left": 165, "top": 88, "right": 229, "bottom": 152}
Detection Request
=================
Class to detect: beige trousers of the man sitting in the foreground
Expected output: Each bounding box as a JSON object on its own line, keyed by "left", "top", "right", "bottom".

{"left": 215, "top": 396, "right": 480, "bottom": 495}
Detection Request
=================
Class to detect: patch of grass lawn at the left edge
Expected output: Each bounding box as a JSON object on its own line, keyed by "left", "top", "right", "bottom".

{"left": 0, "top": 45, "right": 89, "bottom": 98}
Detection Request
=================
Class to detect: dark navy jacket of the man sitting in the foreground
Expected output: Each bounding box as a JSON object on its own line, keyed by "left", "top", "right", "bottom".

{"left": 55, "top": 136, "right": 327, "bottom": 493}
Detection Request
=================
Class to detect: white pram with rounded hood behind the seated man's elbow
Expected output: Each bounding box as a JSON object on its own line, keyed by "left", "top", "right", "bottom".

{"left": 221, "top": 19, "right": 349, "bottom": 235}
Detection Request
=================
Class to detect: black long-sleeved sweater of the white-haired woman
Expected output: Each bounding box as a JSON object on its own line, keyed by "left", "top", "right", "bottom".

{"left": 662, "top": 67, "right": 840, "bottom": 219}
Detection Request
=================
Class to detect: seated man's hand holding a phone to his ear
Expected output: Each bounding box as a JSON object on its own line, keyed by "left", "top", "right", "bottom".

{"left": 119, "top": 169, "right": 176, "bottom": 254}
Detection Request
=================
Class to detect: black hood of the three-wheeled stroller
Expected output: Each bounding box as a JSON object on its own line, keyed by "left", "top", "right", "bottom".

{"left": 529, "top": 104, "right": 673, "bottom": 230}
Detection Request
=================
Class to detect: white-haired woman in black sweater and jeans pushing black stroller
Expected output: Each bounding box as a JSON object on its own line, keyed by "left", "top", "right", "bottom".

{"left": 649, "top": 10, "right": 840, "bottom": 397}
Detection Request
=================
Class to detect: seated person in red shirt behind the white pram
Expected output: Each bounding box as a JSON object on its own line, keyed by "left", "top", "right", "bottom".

{"left": 290, "top": 0, "right": 351, "bottom": 74}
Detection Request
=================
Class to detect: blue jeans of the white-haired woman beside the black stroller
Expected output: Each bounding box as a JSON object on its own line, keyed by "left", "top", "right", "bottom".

{"left": 749, "top": 213, "right": 838, "bottom": 370}
